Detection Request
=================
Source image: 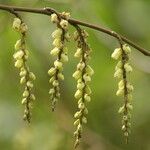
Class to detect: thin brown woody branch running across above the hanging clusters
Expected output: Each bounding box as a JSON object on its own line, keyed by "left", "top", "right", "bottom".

{"left": 0, "top": 4, "right": 150, "bottom": 56}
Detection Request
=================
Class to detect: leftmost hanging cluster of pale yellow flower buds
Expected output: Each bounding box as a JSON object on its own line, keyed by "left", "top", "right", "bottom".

{"left": 13, "top": 18, "right": 35, "bottom": 123}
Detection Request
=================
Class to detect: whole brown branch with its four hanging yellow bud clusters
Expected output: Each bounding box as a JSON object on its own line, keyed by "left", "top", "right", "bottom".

{"left": 0, "top": 5, "right": 150, "bottom": 148}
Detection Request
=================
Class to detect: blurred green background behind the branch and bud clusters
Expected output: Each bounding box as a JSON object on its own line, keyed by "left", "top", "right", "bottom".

{"left": 0, "top": 0, "right": 150, "bottom": 150}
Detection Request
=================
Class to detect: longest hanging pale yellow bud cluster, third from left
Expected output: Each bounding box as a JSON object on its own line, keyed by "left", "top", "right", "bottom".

{"left": 73, "top": 30, "right": 94, "bottom": 147}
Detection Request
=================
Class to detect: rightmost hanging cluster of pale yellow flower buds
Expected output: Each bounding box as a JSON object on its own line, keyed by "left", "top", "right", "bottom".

{"left": 111, "top": 44, "right": 133, "bottom": 141}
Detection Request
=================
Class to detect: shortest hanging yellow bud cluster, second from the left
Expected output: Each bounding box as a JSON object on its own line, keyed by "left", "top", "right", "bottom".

{"left": 48, "top": 12, "right": 70, "bottom": 111}
